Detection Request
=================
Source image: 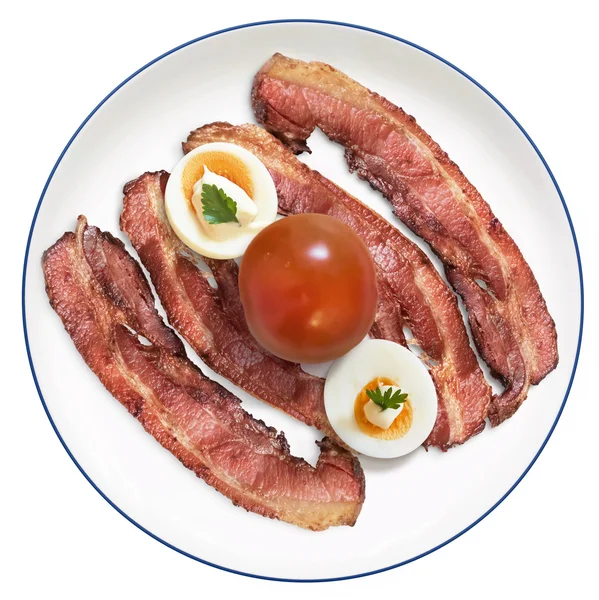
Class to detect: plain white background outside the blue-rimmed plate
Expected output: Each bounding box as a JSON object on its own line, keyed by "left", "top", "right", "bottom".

{"left": 0, "top": 0, "right": 599, "bottom": 600}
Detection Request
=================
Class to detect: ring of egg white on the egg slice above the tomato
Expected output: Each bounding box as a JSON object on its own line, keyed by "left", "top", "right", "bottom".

{"left": 165, "top": 142, "right": 278, "bottom": 259}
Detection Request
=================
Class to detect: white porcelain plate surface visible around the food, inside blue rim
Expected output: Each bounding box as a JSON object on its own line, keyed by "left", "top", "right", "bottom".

{"left": 23, "top": 22, "right": 582, "bottom": 580}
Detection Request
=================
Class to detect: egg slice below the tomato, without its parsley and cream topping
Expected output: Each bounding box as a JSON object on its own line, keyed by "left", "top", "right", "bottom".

{"left": 324, "top": 339, "right": 437, "bottom": 458}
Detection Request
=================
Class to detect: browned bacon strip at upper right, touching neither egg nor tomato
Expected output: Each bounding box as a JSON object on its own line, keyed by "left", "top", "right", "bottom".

{"left": 252, "top": 54, "right": 558, "bottom": 425}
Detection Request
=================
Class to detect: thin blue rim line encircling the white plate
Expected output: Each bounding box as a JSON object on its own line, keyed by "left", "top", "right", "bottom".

{"left": 21, "top": 19, "right": 584, "bottom": 583}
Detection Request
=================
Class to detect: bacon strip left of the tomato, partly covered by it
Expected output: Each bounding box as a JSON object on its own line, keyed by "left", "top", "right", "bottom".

{"left": 121, "top": 171, "right": 343, "bottom": 445}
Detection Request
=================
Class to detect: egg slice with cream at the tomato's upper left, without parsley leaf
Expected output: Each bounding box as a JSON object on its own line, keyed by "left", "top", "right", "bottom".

{"left": 165, "top": 142, "right": 278, "bottom": 259}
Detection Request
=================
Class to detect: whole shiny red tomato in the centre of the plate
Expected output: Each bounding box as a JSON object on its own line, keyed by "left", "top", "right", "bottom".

{"left": 239, "top": 214, "right": 377, "bottom": 363}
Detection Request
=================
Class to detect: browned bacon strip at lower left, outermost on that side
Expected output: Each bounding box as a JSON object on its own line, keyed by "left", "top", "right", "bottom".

{"left": 43, "top": 217, "right": 364, "bottom": 530}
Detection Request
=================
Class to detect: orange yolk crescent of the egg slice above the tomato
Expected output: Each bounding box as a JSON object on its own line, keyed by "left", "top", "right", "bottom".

{"left": 181, "top": 152, "right": 254, "bottom": 204}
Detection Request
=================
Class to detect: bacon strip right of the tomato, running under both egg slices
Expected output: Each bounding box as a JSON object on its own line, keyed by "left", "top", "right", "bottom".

{"left": 183, "top": 123, "right": 491, "bottom": 450}
